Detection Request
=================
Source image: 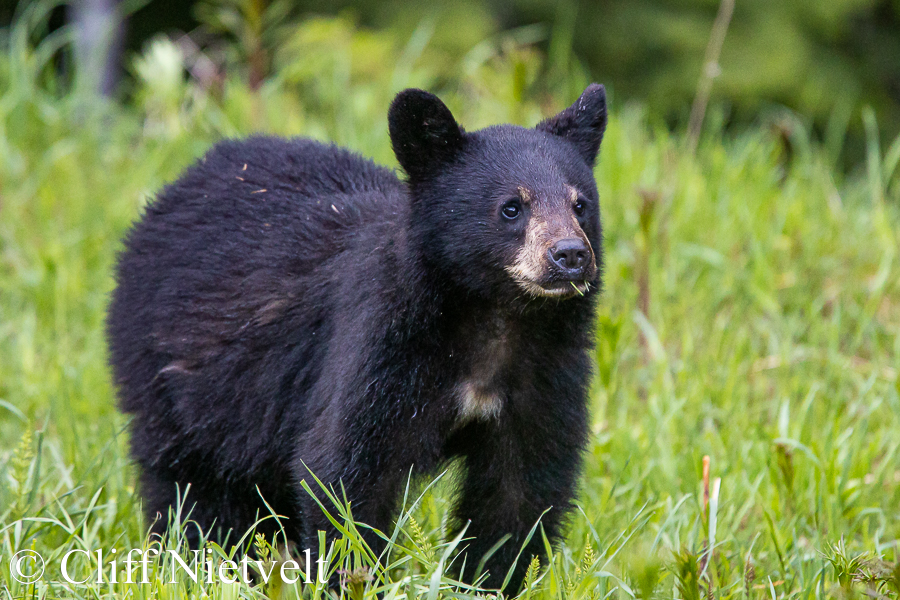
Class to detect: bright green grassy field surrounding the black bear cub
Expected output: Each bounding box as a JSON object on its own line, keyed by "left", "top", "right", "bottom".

{"left": 0, "top": 8, "right": 900, "bottom": 600}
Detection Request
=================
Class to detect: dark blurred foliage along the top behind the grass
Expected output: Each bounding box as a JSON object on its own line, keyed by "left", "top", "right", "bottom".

{"left": 0, "top": 0, "right": 900, "bottom": 167}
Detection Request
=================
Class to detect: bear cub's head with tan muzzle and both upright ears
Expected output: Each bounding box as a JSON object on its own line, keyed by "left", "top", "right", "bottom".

{"left": 388, "top": 84, "right": 606, "bottom": 299}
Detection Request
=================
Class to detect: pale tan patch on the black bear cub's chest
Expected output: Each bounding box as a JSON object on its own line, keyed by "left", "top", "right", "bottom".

{"left": 457, "top": 334, "right": 509, "bottom": 422}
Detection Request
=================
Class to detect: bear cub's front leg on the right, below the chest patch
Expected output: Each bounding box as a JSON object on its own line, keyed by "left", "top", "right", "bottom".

{"left": 454, "top": 417, "right": 584, "bottom": 595}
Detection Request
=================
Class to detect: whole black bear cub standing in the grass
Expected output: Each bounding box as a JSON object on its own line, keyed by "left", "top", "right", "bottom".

{"left": 108, "top": 84, "right": 606, "bottom": 592}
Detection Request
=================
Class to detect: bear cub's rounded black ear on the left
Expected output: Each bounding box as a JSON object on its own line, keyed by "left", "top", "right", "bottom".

{"left": 388, "top": 89, "right": 463, "bottom": 181}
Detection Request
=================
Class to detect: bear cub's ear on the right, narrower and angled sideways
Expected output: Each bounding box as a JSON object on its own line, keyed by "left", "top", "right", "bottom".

{"left": 535, "top": 83, "right": 606, "bottom": 167}
